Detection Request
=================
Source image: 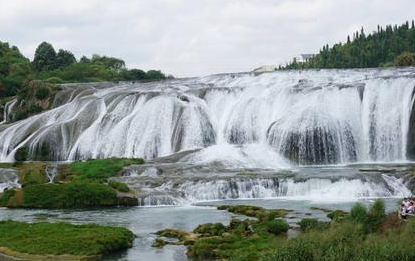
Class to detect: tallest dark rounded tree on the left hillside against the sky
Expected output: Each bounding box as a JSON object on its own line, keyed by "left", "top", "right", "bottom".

{"left": 33, "top": 42, "right": 56, "bottom": 72}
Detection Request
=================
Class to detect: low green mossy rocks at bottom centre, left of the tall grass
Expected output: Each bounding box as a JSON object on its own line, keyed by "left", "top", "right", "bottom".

{"left": 153, "top": 206, "right": 289, "bottom": 260}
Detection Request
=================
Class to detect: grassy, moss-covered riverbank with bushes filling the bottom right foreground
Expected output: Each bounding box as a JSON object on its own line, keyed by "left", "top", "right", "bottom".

{"left": 153, "top": 200, "right": 415, "bottom": 261}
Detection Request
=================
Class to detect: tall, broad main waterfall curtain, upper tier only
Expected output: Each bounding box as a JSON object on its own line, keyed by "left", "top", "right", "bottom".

{"left": 0, "top": 68, "right": 415, "bottom": 165}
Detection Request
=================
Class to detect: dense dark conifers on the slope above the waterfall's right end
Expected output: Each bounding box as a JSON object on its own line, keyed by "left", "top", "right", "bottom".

{"left": 284, "top": 21, "right": 415, "bottom": 69}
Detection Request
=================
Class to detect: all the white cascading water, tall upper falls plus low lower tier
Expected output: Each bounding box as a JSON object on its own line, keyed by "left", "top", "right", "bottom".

{"left": 0, "top": 68, "right": 415, "bottom": 205}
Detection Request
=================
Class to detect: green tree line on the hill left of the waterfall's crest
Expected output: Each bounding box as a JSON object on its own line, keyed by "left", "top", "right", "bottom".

{"left": 0, "top": 41, "right": 172, "bottom": 98}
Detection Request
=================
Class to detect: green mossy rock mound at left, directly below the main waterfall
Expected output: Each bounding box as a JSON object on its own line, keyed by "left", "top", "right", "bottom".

{"left": 0, "top": 158, "right": 144, "bottom": 208}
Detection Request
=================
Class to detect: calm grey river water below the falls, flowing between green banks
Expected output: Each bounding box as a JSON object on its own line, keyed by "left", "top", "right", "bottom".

{"left": 0, "top": 199, "right": 406, "bottom": 261}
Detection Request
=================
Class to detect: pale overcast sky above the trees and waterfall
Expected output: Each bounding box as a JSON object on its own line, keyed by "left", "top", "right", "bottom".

{"left": 0, "top": 0, "right": 415, "bottom": 77}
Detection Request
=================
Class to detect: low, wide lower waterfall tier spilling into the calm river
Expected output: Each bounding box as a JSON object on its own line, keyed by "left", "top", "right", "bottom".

{"left": 132, "top": 175, "right": 411, "bottom": 206}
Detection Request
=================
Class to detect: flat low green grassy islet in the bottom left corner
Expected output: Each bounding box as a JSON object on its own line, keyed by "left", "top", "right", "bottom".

{"left": 0, "top": 221, "right": 135, "bottom": 256}
